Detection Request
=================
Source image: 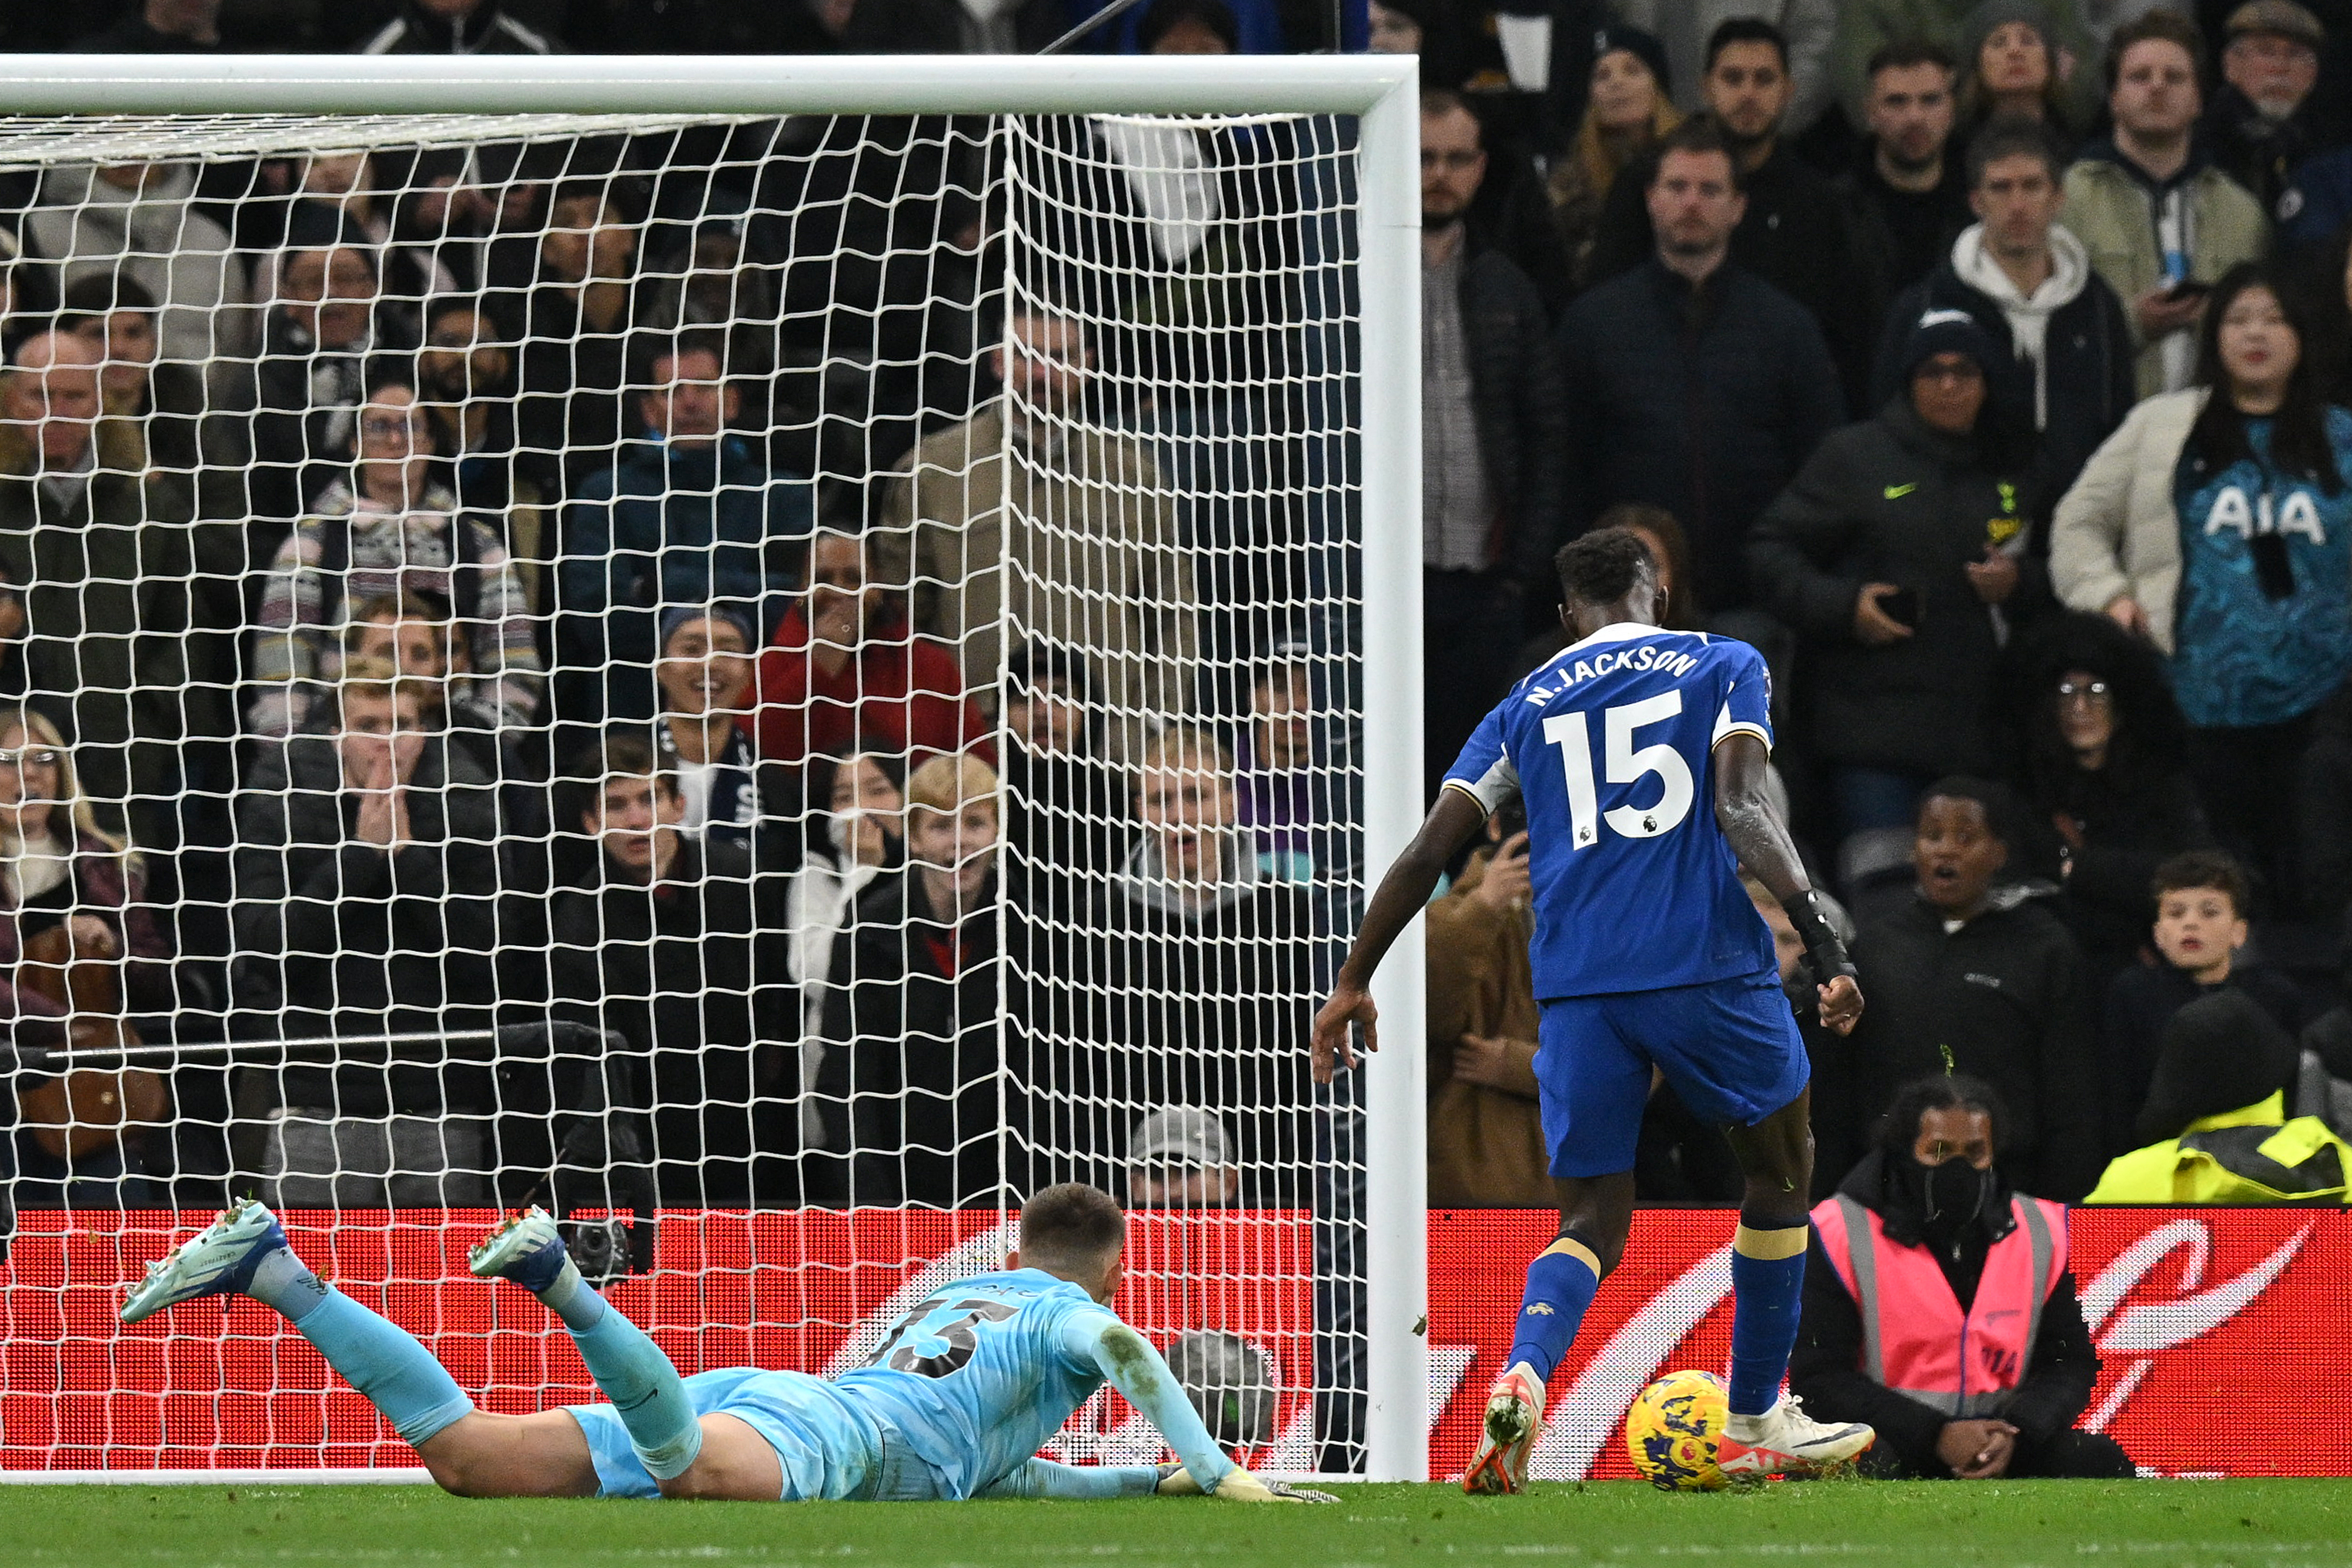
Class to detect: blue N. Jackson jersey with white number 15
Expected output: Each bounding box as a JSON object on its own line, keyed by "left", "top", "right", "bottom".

{"left": 1446, "top": 623, "right": 1776, "bottom": 1001}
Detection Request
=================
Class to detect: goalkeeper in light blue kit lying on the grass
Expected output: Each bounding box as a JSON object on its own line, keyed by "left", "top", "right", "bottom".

{"left": 122, "top": 1182, "right": 1331, "bottom": 1502}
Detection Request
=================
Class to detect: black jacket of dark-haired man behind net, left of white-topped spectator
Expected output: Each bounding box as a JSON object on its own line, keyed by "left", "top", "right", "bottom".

{"left": 546, "top": 837, "right": 800, "bottom": 1208}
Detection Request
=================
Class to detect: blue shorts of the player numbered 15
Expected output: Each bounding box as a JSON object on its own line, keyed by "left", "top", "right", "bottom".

{"left": 1536, "top": 971, "right": 1811, "bottom": 1175}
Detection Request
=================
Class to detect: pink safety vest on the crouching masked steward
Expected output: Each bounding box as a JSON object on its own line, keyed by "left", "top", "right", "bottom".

{"left": 1813, "top": 1196, "right": 2067, "bottom": 1420}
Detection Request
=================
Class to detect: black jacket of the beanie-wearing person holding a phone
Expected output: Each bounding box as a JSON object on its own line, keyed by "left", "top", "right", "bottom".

{"left": 1748, "top": 400, "right": 2049, "bottom": 774}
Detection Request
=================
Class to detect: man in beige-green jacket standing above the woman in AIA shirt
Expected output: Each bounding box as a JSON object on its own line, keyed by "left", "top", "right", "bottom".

{"left": 2065, "top": 9, "right": 2270, "bottom": 397}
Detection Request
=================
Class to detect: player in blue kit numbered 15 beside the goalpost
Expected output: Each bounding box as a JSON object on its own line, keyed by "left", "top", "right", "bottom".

{"left": 1312, "top": 529, "right": 1875, "bottom": 1493}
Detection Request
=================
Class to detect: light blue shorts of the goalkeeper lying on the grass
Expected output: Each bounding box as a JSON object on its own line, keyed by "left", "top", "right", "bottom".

{"left": 564, "top": 1366, "right": 946, "bottom": 1502}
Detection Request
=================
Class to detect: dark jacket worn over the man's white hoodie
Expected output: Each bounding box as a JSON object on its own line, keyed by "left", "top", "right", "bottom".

{"left": 1870, "top": 245, "right": 2140, "bottom": 506}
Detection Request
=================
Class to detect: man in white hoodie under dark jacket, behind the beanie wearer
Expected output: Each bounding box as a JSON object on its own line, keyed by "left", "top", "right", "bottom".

{"left": 1872, "top": 120, "right": 2138, "bottom": 506}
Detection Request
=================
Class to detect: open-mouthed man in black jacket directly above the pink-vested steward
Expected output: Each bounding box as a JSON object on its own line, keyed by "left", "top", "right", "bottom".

{"left": 1851, "top": 778, "right": 2103, "bottom": 1201}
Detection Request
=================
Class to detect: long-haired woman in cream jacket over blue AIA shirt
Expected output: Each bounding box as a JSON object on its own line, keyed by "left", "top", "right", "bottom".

{"left": 2051, "top": 263, "right": 2352, "bottom": 917}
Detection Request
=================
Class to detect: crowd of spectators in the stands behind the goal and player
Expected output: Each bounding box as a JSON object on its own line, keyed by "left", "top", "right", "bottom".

{"left": 0, "top": 0, "right": 2352, "bottom": 1241}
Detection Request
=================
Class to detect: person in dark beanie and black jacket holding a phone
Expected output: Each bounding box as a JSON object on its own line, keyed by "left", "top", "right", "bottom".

{"left": 1748, "top": 308, "right": 2049, "bottom": 858}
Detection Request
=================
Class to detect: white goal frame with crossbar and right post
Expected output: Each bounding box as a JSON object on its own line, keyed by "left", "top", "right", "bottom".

{"left": 0, "top": 54, "right": 1432, "bottom": 1483}
